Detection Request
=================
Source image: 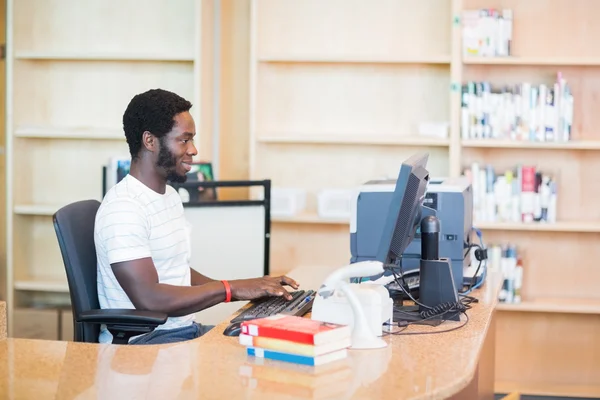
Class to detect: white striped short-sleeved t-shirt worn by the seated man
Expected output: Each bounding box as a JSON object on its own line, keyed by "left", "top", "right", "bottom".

{"left": 94, "top": 175, "right": 194, "bottom": 343}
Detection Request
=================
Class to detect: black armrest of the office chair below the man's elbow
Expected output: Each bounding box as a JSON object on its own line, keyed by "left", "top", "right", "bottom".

{"left": 77, "top": 309, "right": 168, "bottom": 327}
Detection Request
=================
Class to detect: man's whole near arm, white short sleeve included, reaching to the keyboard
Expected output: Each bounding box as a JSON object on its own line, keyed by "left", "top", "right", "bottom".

{"left": 96, "top": 199, "right": 298, "bottom": 317}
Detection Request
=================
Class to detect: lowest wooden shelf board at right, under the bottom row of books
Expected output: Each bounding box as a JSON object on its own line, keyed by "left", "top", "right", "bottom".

{"left": 497, "top": 298, "right": 600, "bottom": 314}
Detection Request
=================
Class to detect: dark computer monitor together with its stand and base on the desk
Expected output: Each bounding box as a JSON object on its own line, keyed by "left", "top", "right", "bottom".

{"left": 364, "top": 154, "right": 463, "bottom": 321}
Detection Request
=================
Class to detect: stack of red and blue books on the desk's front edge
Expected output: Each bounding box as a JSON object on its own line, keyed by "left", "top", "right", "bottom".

{"left": 239, "top": 314, "right": 352, "bottom": 366}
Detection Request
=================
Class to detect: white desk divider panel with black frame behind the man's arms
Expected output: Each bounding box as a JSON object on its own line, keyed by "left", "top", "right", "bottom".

{"left": 173, "top": 180, "right": 271, "bottom": 325}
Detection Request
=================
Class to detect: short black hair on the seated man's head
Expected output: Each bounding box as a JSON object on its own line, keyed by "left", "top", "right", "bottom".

{"left": 123, "top": 89, "right": 192, "bottom": 158}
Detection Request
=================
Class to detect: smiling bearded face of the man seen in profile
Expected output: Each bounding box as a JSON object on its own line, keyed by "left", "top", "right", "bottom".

{"left": 156, "top": 112, "right": 198, "bottom": 183}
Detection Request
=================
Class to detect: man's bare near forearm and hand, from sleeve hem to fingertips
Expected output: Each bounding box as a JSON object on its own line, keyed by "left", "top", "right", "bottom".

{"left": 111, "top": 258, "right": 298, "bottom": 317}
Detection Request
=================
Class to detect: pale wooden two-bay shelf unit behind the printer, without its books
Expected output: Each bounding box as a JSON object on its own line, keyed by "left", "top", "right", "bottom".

{"left": 249, "top": 0, "right": 600, "bottom": 396}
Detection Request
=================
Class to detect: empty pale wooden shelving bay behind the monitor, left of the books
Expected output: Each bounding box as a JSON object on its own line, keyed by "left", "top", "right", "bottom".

{"left": 249, "top": 0, "right": 452, "bottom": 276}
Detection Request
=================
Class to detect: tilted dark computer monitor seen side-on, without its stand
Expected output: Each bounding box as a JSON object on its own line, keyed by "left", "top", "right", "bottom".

{"left": 376, "top": 153, "right": 429, "bottom": 266}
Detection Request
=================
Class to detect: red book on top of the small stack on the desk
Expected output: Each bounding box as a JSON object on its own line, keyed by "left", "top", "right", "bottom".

{"left": 241, "top": 314, "right": 351, "bottom": 345}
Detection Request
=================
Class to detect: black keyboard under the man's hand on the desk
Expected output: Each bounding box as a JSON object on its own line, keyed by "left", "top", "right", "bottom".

{"left": 231, "top": 290, "right": 316, "bottom": 323}
